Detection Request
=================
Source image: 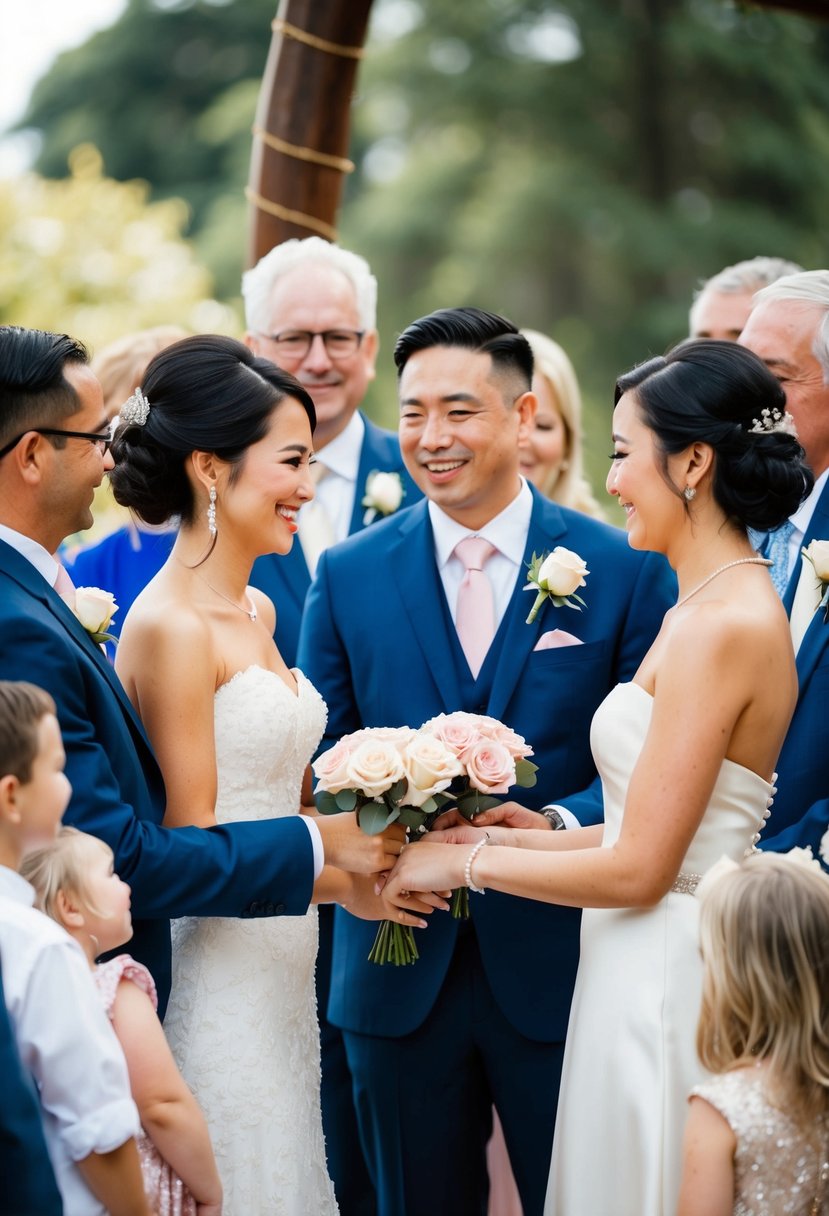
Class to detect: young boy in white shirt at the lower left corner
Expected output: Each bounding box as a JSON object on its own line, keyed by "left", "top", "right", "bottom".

{"left": 0, "top": 681, "right": 150, "bottom": 1216}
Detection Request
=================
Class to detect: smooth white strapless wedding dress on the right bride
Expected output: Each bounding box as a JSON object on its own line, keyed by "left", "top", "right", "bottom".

{"left": 545, "top": 683, "right": 774, "bottom": 1216}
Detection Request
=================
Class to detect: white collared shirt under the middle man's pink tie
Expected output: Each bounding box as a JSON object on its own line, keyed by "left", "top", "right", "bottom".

{"left": 428, "top": 478, "right": 532, "bottom": 630}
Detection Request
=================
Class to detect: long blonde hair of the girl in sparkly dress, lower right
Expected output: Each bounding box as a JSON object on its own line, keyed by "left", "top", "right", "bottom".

{"left": 697, "top": 854, "right": 829, "bottom": 1126}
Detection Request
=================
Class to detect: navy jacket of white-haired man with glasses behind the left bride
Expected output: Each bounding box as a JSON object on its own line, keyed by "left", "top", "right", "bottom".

{"left": 250, "top": 417, "right": 421, "bottom": 668}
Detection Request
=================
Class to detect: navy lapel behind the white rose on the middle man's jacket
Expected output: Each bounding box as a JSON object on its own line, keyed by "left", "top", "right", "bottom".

{"left": 489, "top": 491, "right": 566, "bottom": 717}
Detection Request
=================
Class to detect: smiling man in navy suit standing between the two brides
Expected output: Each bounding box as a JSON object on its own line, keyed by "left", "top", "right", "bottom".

{"left": 299, "top": 309, "right": 673, "bottom": 1216}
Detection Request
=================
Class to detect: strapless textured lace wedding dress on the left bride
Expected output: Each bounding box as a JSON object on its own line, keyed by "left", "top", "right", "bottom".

{"left": 164, "top": 666, "right": 337, "bottom": 1216}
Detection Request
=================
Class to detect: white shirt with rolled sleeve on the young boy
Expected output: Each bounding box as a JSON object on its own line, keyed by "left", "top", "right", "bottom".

{"left": 0, "top": 866, "right": 140, "bottom": 1216}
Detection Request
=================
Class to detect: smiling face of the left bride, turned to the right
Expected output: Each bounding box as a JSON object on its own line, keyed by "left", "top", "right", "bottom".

{"left": 216, "top": 398, "right": 314, "bottom": 557}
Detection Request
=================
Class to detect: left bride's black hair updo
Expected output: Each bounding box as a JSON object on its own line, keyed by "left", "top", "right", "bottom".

{"left": 109, "top": 333, "right": 316, "bottom": 524}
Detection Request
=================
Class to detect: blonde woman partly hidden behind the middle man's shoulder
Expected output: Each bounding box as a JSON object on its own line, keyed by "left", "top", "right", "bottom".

{"left": 520, "top": 330, "right": 607, "bottom": 519}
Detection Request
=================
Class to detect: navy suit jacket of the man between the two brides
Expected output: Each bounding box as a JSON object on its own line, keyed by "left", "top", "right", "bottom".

{"left": 299, "top": 491, "right": 676, "bottom": 1042}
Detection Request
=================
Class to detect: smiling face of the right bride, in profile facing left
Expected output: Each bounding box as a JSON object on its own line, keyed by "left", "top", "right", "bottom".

{"left": 607, "top": 393, "right": 684, "bottom": 553}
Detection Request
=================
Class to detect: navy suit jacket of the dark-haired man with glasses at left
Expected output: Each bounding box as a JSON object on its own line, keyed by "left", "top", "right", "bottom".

{"left": 0, "top": 541, "right": 314, "bottom": 1012}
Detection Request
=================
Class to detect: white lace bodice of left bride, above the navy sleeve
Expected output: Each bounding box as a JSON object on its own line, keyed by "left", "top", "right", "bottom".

{"left": 214, "top": 666, "right": 327, "bottom": 823}
